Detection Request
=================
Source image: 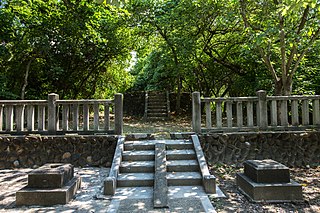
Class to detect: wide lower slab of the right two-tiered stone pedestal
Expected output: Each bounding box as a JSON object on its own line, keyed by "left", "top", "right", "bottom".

{"left": 237, "top": 173, "right": 303, "bottom": 203}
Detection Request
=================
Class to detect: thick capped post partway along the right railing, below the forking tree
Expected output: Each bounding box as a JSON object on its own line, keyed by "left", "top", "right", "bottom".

{"left": 257, "top": 90, "right": 268, "bottom": 129}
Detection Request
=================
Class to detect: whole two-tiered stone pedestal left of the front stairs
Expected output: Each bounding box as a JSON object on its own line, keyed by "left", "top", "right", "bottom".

{"left": 16, "top": 163, "right": 81, "bottom": 206}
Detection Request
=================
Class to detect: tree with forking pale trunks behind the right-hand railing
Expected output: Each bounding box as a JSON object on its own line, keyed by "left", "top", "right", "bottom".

{"left": 239, "top": 0, "right": 320, "bottom": 95}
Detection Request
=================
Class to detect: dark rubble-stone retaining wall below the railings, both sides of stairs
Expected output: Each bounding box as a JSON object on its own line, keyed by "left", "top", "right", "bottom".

{"left": 0, "top": 131, "right": 320, "bottom": 169}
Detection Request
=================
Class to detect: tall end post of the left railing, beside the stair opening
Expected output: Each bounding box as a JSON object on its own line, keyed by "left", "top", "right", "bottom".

{"left": 114, "top": 93, "right": 123, "bottom": 135}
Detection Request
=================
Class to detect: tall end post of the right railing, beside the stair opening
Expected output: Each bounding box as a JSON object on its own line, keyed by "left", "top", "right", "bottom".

{"left": 192, "top": 92, "right": 201, "bottom": 133}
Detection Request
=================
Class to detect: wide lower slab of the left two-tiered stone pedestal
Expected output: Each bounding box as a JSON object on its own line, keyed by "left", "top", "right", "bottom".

{"left": 16, "top": 176, "right": 81, "bottom": 206}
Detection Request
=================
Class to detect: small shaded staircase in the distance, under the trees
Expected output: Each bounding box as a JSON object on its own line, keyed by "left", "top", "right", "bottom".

{"left": 144, "top": 91, "right": 170, "bottom": 121}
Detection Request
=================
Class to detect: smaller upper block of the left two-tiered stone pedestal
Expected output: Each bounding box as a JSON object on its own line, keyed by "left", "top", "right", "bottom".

{"left": 28, "top": 163, "right": 74, "bottom": 188}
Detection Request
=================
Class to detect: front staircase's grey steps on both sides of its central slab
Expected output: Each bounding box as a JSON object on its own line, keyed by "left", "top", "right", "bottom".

{"left": 117, "top": 140, "right": 202, "bottom": 187}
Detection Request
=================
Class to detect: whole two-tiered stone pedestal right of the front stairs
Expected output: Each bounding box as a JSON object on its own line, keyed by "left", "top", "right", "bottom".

{"left": 237, "top": 160, "right": 303, "bottom": 202}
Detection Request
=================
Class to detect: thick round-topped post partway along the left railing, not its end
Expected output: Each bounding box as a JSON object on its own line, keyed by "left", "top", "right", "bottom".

{"left": 48, "top": 93, "right": 59, "bottom": 134}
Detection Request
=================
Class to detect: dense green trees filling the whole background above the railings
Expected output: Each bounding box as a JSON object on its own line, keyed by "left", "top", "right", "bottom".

{"left": 0, "top": 0, "right": 320, "bottom": 99}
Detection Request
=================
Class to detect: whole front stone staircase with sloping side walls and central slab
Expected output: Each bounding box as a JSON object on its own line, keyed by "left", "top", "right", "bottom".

{"left": 104, "top": 135, "right": 219, "bottom": 212}
